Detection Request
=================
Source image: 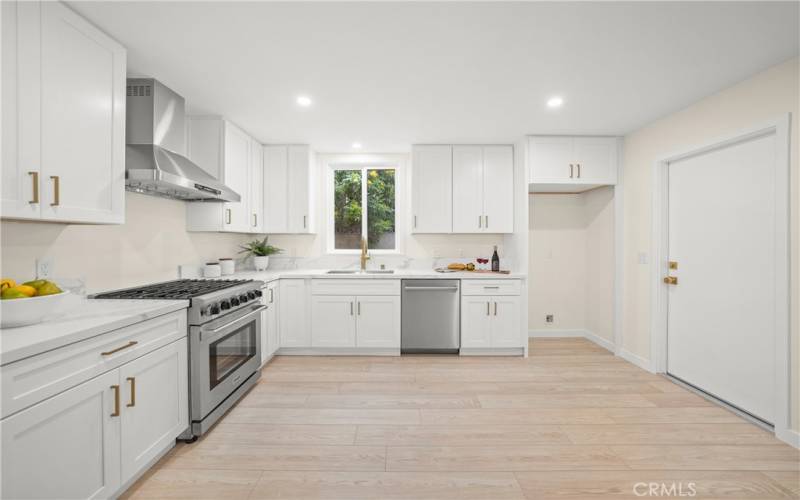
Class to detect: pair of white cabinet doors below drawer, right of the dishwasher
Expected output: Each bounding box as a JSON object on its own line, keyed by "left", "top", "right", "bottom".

{"left": 461, "top": 295, "right": 522, "bottom": 349}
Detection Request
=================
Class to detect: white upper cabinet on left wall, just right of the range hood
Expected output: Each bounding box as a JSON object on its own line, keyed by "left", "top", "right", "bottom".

{"left": 186, "top": 116, "right": 264, "bottom": 233}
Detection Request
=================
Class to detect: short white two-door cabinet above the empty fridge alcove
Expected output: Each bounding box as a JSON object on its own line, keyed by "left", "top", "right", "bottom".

{"left": 528, "top": 136, "right": 617, "bottom": 193}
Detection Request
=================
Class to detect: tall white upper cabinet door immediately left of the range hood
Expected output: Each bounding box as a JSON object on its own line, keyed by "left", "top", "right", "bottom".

{"left": 38, "top": 2, "right": 126, "bottom": 223}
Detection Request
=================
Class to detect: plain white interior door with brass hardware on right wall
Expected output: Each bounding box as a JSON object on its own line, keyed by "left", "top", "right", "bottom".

{"left": 665, "top": 133, "right": 779, "bottom": 422}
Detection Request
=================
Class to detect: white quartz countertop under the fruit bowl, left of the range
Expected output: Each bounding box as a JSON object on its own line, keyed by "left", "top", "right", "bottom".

{"left": 0, "top": 295, "right": 189, "bottom": 365}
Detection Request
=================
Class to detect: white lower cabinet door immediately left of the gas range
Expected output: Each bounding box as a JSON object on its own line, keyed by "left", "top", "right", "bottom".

{"left": 119, "top": 338, "right": 189, "bottom": 484}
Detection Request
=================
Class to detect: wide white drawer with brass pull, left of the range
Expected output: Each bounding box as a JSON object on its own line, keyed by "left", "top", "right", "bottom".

{"left": 0, "top": 310, "right": 186, "bottom": 418}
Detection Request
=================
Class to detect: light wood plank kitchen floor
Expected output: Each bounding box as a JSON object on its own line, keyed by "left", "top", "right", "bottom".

{"left": 126, "top": 339, "right": 800, "bottom": 500}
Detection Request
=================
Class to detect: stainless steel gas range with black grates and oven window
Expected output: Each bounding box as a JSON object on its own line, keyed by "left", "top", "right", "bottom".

{"left": 92, "top": 280, "right": 265, "bottom": 441}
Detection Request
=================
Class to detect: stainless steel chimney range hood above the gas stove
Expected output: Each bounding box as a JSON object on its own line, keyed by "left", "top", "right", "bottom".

{"left": 125, "top": 78, "right": 241, "bottom": 202}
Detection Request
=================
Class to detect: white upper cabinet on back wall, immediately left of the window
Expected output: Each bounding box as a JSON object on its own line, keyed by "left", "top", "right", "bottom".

{"left": 263, "top": 145, "right": 314, "bottom": 234}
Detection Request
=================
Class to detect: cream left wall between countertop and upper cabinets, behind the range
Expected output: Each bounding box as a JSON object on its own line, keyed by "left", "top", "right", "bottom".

{"left": 0, "top": 193, "right": 251, "bottom": 293}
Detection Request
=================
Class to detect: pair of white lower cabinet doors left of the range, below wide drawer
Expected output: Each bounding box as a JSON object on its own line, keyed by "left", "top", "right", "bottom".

{"left": 0, "top": 322, "right": 189, "bottom": 498}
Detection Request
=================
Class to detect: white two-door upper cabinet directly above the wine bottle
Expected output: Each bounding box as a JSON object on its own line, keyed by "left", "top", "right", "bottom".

{"left": 453, "top": 146, "right": 514, "bottom": 233}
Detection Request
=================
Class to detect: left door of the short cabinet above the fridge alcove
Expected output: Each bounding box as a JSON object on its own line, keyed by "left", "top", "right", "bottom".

{"left": 528, "top": 136, "right": 577, "bottom": 183}
